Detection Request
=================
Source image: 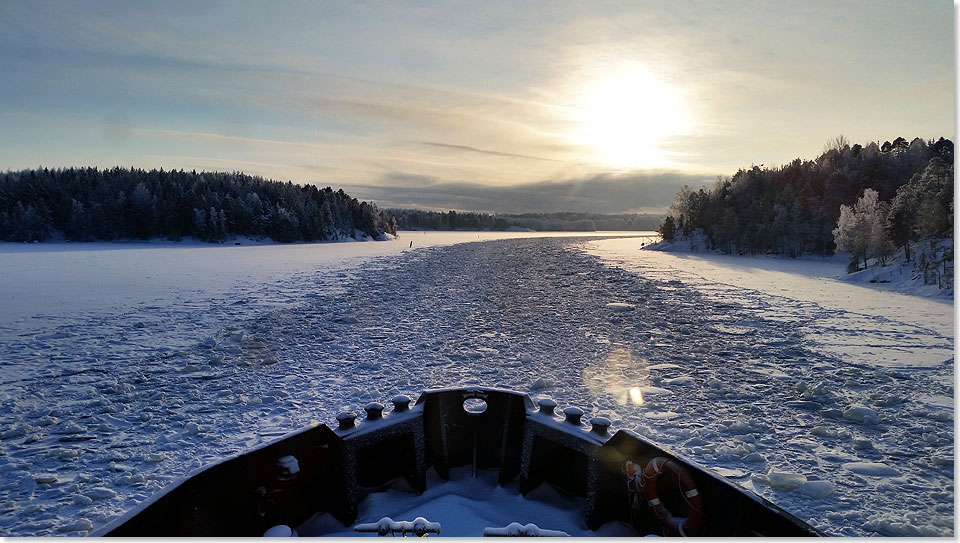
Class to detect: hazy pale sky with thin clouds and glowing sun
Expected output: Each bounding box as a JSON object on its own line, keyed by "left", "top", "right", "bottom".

{"left": 0, "top": 0, "right": 956, "bottom": 212}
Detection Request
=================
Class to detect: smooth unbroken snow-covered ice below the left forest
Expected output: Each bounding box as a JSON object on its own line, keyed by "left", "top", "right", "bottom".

{"left": 0, "top": 231, "right": 631, "bottom": 326}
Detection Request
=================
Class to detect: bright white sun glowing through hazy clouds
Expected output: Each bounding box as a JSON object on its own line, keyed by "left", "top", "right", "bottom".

{"left": 574, "top": 66, "right": 688, "bottom": 169}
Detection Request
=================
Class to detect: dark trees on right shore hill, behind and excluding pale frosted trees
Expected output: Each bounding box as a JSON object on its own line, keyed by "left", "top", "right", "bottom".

{"left": 656, "top": 136, "right": 953, "bottom": 259}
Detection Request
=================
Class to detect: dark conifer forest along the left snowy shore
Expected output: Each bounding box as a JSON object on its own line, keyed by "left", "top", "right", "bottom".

{"left": 0, "top": 167, "right": 397, "bottom": 242}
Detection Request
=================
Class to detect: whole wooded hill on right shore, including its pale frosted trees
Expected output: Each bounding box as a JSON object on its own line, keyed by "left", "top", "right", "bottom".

{"left": 658, "top": 136, "right": 953, "bottom": 269}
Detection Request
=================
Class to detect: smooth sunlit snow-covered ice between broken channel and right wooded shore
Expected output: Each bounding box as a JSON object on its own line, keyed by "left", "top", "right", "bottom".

{"left": 589, "top": 239, "right": 954, "bottom": 372}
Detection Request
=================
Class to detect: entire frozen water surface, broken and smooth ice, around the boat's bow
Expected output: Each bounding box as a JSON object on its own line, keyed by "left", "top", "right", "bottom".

{"left": 0, "top": 233, "right": 954, "bottom": 535}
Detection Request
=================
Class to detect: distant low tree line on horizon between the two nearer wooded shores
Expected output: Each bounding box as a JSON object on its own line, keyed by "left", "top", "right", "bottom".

{"left": 388, "top": 209, "right": 663, "bottom": 232}
